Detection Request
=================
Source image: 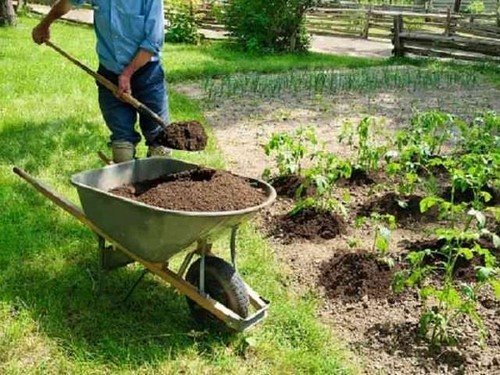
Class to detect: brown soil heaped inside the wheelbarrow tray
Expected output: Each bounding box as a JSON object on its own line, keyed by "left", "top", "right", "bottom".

{"left": 110, "top": 168, "right": 267, "bottom": 212}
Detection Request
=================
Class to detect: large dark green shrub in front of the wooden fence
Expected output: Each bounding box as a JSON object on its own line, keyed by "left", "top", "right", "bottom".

{"left": 225, "top": 0, "right": 315, "bottom": 52}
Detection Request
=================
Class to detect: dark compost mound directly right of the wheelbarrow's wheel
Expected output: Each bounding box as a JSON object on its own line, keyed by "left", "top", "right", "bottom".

{"left": 319, "top": 252, "right": 393, "bottom": 302}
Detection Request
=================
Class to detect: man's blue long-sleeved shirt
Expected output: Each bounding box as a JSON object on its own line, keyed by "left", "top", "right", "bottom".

{"left": 70, "top": 0, "right": 164, "bottom": 74}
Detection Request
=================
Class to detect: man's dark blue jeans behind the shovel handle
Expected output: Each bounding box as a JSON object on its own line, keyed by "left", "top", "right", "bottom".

{"left": 97, "top": 61, "right": 168, "bottom": 146}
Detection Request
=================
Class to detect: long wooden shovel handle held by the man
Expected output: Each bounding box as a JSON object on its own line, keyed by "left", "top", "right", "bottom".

{"left": 45, "top": 40, "right": 168, "bottom": 129}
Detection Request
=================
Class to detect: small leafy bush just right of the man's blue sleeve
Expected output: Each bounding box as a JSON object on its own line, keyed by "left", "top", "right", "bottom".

{"left": 165, "top": 0, "right": 200, "bottom": 44}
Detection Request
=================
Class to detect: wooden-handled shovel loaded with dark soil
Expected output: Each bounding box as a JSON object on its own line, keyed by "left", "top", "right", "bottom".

{"left": 45, "top": 40, "right": 207, "bottom": 151}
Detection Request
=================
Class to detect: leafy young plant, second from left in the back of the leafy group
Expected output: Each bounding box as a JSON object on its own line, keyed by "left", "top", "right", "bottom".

{"left": 339, "top": 117, "right": 387, "bottom": 172}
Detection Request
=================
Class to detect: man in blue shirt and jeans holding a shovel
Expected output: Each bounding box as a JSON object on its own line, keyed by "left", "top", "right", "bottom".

{"left": 32, "top": 0, "right": 169, "bottom": 163}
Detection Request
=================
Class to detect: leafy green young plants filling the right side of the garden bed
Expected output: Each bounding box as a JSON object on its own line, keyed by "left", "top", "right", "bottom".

{"left": 264, "top": 111, "right": 500, "bottom": 346}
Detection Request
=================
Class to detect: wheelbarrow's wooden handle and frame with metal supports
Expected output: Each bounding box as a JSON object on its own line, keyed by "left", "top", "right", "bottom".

{"left": 13, "top": 167, "right": 269, "bottom": 331}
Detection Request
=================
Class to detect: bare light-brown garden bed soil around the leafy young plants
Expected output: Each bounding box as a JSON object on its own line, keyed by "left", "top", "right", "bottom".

{"left": 182, "top": 86, "right": 500, "bottom": 374}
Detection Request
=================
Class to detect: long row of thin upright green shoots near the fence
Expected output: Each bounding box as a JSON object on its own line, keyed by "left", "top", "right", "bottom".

{"left": 203, "top": 66, "right": 479, "bottom": 100}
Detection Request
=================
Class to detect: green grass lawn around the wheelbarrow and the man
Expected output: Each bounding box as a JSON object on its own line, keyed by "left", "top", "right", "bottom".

{"left": 0, "top": 18, "right": 360, "bottom": 374}
